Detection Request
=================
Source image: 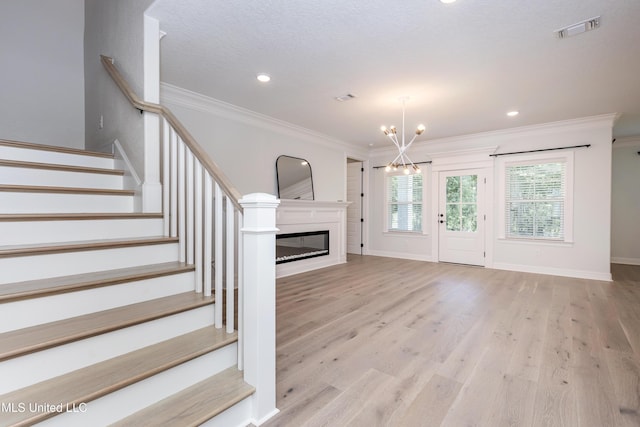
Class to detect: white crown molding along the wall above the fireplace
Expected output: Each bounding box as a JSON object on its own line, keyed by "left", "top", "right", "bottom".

{"left": 160, "top": 82, "right": 367, "bottom": 156}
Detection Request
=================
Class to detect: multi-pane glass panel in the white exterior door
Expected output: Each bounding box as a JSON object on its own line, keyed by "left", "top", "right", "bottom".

{"left": 446, "top": 175, "right": 478, "bottom": 233}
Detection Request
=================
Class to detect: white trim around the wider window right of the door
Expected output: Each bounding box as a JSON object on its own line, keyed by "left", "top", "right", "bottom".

{"left": 496, "top": 151, "right": 574, "bottom": 244}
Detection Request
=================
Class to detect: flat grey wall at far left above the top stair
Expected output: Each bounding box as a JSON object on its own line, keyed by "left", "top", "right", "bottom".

{"left": 0, "top": 0, "right": 84, "bottom": 148}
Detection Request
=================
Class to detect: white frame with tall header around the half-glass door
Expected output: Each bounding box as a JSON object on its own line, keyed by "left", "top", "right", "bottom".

{"left": 428, "top": 146, "right": 498, "bottom": 268}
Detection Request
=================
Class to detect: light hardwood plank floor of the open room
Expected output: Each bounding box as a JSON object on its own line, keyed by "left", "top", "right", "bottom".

{"left": 265, "top": 256, "right": 640, "bottom": 427}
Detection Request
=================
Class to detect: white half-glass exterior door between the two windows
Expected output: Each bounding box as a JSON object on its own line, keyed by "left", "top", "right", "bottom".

{"left": 438, "top": 169, "right": 486, "bottom": 266}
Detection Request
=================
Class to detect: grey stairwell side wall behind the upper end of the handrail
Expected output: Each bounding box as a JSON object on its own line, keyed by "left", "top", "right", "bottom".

{"left": 84, "top": 0, "right": 153, "bottom": 176}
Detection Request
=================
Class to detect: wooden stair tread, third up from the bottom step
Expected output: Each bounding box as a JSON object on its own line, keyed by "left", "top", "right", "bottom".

{"left": 0, "top": 292, "right": 214, "bottom": 361}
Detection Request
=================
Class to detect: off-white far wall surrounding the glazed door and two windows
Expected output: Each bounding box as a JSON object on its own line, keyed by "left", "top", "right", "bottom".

{"left": 368, "top": 115, "right": 614, "bottom": 280}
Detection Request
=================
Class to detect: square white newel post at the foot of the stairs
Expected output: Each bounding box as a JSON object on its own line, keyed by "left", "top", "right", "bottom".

{"left": 239, "top": 193, "right": 280, "bottom": 425}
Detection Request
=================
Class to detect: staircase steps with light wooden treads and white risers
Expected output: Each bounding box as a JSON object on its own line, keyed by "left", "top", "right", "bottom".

{"left": 0, "top": 140, "right": 254, "bottom": 427}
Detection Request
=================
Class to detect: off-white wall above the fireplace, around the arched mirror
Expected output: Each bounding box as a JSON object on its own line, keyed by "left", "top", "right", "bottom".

{"left": 160, "top": 84, "right": 364, "bottom": 201}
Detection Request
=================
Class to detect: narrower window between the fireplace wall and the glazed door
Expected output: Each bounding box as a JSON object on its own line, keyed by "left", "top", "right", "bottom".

{"left": 386, "top": 174, "right": 423, "bottom": 231}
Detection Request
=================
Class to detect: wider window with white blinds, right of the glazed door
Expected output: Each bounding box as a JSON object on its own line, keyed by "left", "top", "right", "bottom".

{"left": 505, "top": 159, "right": 570, "bottom": 241}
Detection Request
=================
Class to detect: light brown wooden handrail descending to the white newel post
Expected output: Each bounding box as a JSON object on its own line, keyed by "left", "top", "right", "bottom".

{"left": 100, "top": 55, "right": 242, "bottom": 212}
